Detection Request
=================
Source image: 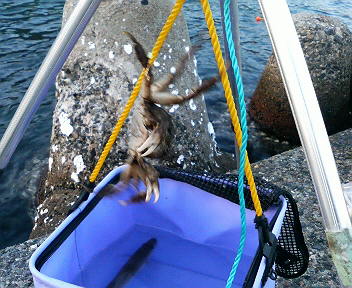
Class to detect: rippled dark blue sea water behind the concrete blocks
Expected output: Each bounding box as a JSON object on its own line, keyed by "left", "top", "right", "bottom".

{"left": 0, "top": 0, "right": 352, "bottom": 249}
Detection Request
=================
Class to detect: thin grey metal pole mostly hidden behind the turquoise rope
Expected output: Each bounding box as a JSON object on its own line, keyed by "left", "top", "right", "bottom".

{"left": 220, "top": 0, "right": 242, "bottom": 168}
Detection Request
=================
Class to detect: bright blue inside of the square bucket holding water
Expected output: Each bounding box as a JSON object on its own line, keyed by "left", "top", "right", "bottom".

{"left": 40, "top": 179, "right": 280, "bottom": 288}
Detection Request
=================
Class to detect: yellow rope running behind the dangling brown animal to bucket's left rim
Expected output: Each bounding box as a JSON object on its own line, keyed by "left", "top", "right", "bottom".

{"left": 89, "top": 0, "right": 186, "bottom": 182}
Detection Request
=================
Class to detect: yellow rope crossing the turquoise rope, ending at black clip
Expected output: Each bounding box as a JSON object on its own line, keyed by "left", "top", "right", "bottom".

{"left": 200, "top": 0, "right": 263, "bottom": 216}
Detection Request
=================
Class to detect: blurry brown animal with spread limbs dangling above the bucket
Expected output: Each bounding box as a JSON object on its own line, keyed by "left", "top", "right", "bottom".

{"left": 108, "top": 32, "right": 217, "bottom": 204}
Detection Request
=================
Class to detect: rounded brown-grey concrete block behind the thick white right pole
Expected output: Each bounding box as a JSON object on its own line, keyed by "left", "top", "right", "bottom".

{"left": 249, "top": 14, "right": 352, "bottom": 142}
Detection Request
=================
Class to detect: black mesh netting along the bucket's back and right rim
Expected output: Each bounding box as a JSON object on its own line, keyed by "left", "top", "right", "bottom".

{"left": 157, "top": 167, "right": 309, "bottom": 287}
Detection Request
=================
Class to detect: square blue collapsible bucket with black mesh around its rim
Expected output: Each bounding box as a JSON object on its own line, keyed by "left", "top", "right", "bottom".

{"left": 30, "top": 167, "right": 308, "bottom": 288}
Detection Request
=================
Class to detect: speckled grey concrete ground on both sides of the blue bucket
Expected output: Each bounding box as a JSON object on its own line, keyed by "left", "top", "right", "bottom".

{"left": 0, "top": 129, "right": 352, "bottom": 288}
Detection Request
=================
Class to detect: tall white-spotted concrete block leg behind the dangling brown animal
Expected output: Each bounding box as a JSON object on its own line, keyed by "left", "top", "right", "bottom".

{"left": 31, "top": 0, "right": 233, "bottom": 237}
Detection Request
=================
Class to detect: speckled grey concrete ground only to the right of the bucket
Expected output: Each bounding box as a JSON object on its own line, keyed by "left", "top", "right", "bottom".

{"left": 252, "top": 129, "right": 352, "bottom": 288}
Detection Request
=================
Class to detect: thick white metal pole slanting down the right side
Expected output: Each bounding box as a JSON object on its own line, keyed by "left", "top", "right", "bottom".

{"left": 259, "top": 0, "right": 352, "bottom": 287}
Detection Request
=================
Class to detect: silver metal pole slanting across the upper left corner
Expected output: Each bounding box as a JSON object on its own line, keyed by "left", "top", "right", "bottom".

{"left": 0, "top": 0, "right": 102, "bottom": 169}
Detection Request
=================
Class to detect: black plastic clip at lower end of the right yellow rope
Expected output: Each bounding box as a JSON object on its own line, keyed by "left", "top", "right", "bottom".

{"left": 254, "top": 215, "right": 277, "bottom": 286}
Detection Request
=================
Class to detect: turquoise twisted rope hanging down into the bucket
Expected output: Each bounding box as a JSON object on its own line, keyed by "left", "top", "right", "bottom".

{"left": 224, "top": 0, "right": 248, "bottom": 288}
